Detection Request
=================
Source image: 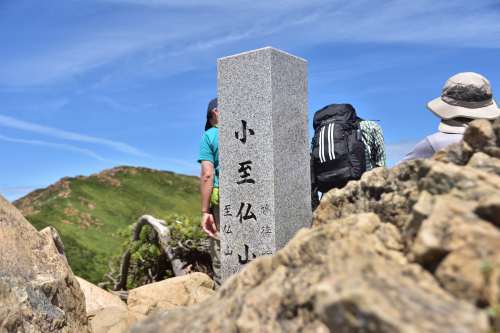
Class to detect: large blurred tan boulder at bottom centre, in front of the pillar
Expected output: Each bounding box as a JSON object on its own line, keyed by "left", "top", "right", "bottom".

{"left": 132, "top": 214, "right": 488, "bottom": 333}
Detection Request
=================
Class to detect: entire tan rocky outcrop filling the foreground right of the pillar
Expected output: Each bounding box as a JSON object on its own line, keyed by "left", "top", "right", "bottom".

{"left": 132, "top": 120, "right": 500, "bottom": 333}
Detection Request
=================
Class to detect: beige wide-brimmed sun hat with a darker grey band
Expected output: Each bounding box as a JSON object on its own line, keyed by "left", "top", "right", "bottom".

{"left": 427, "top": 72, "right": 500, "bottom": 119}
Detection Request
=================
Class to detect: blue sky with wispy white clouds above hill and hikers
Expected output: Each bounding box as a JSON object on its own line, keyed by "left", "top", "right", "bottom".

{"left": 0, "top": 0, "right": 500, "bottom": 200}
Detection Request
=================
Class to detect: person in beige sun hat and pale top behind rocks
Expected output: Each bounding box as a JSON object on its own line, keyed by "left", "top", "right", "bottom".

{"left": 401, "top": 72, "right": 500, "bottom": 162}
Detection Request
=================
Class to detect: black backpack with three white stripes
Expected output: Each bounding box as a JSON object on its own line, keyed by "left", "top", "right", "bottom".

{"left": 311, "top": 104, "right": 366, "bottom": 193}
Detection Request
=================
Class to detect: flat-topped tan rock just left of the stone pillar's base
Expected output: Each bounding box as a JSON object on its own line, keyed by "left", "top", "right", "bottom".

{"left": 127, "top": 272, "right": 215, "bottom": 321}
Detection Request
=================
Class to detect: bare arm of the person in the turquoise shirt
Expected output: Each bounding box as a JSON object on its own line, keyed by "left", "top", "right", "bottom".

{"left": 200, "top": 161, "right": 217, "bottom": 238}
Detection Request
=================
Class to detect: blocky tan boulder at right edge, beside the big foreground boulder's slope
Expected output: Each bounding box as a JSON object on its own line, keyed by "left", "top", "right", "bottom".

{"left": 410, "top": 195, "right": 500, "bottom": 306}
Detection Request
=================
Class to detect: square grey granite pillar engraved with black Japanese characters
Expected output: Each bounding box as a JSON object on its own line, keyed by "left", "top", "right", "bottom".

{"left": 217, "top": 47, "right": 312, "bottom": 280}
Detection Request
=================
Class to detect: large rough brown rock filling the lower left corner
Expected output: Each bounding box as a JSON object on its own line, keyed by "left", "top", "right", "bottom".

{"left": 0, "top": 193, "right": 89, "bottom": 333}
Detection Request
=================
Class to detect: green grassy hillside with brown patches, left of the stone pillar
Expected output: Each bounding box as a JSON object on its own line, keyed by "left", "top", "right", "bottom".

{"left": 14, "top": 167, "right": 199, "bottom": 283}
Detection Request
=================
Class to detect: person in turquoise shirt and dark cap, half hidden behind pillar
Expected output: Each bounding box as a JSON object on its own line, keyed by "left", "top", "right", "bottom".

{"left": 198, "top": 98, "right": 221, "bottom": 285}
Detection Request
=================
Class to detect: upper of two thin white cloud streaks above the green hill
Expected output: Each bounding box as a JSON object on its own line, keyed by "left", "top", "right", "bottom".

{"left": 0, "top": 115, "right": 149, "bottom": 157}
